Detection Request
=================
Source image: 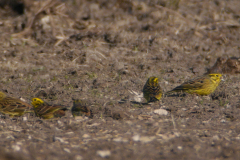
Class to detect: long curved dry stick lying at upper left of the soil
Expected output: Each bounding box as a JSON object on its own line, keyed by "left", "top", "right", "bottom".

{"left": 12, "top": 0, "right": 57, "bottom": 37}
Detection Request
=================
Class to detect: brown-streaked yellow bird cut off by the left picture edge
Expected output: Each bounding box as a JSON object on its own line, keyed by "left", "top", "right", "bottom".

{"left": 0, "top": 92, "right": 32, "bottom": 117}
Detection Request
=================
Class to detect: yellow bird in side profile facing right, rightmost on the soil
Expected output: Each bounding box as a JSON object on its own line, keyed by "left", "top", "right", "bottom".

{"left": 166, "top": 73, "right": 222, "bottom": 95}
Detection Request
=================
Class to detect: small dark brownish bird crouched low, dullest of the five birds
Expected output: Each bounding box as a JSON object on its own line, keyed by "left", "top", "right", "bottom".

{"left": 72, "top": 99, "right": 93, "bottom": 118}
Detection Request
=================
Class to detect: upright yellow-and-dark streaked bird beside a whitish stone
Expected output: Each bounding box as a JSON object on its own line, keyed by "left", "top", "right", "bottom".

{"left": 143, "top": 77, "right": 162, "bottom": 102}
